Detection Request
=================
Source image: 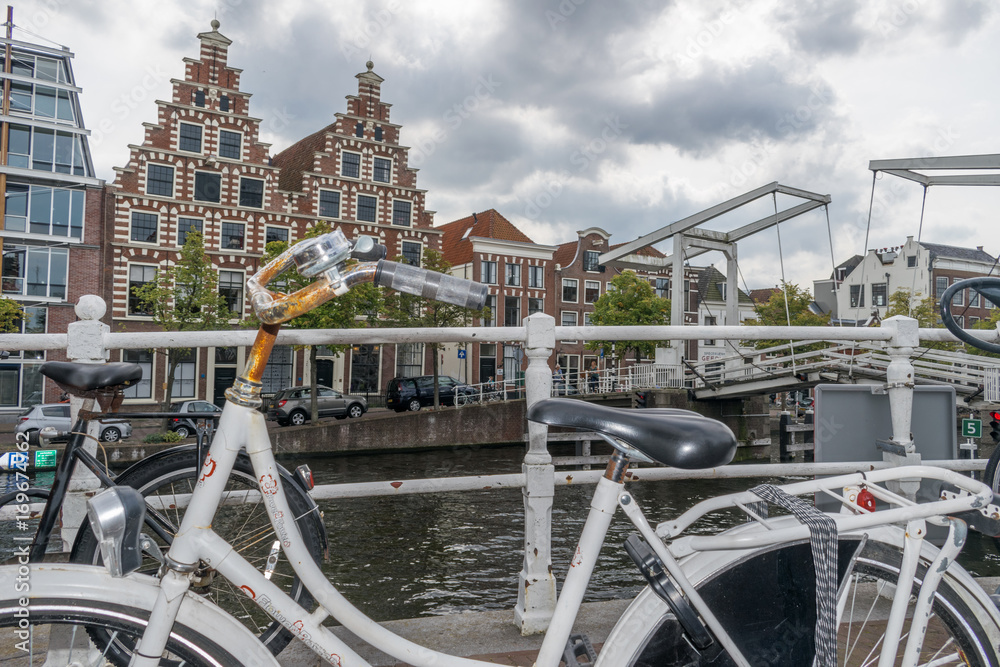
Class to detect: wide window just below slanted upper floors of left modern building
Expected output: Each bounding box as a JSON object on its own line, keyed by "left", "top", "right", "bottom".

{"left": 4, "top": 182, "right": 86, "bottom": 238}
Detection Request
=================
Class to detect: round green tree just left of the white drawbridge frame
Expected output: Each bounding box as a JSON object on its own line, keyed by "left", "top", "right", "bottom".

{"left": 586, "top": 271, "right": 670, "bottom": 362}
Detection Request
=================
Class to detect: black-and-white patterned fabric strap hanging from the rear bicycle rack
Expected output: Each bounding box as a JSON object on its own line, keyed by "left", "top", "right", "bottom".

{"left": 750, "top": 484, "right": 838, "bottom": 667}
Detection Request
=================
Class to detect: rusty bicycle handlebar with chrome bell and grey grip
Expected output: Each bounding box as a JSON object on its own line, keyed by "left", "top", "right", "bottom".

{"left": 247, "top": 230, "right": 488, "bottom": 324}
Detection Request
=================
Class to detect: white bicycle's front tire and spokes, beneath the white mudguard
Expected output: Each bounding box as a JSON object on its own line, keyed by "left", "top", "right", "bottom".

{"left": 0, "top": 596, "right": 239, "bottom": 667}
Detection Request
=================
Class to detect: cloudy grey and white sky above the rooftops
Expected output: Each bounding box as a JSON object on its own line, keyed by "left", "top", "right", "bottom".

{"left": 12, "top": 0, "right": 1000, "bottom": 288}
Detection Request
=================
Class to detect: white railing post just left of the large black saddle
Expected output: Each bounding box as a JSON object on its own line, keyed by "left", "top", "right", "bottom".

{"left": 514, "top": 313, "right": 556, "bottom": 635}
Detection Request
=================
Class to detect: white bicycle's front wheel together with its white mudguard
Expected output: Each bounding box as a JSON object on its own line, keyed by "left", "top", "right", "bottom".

{"left": 0, "top": 563, "right": 274, "bottom": 667}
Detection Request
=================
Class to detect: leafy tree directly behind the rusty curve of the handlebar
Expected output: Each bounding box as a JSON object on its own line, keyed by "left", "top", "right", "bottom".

{"left": 256, "top": 220, "right": 382, "bottom": 422}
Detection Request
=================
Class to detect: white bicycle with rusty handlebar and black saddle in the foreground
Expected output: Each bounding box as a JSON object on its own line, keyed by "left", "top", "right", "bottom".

{"left": 0, "top": 232, "right": 1000, "bottom": 667}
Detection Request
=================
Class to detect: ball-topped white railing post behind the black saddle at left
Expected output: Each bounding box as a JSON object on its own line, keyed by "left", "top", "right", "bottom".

{"left": 62, "top": 294, "right": 111, "bottom": 552}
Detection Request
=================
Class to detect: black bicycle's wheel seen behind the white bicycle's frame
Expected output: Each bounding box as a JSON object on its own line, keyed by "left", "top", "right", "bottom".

{"left": 70, "top": 447, "right": 325, "bottom": 655}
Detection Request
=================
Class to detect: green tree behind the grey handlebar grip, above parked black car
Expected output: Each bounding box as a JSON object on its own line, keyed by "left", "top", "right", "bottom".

{"left": 382, "top": 249, "right": 482, "bottom": 410}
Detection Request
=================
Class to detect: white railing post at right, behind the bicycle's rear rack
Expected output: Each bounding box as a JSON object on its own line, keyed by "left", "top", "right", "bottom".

{"left": 882, "top": 315, "right": 920, "bottom": 498}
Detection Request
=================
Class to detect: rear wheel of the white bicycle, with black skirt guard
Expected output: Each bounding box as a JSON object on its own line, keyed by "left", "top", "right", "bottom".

{"left": 601, "top": 538, "right": 1000, "bottom": 667}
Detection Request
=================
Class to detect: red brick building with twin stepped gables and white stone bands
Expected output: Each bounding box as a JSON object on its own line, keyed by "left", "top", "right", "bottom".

{"left": 104, "top": 21, "right": 441, "bottom": 404}
